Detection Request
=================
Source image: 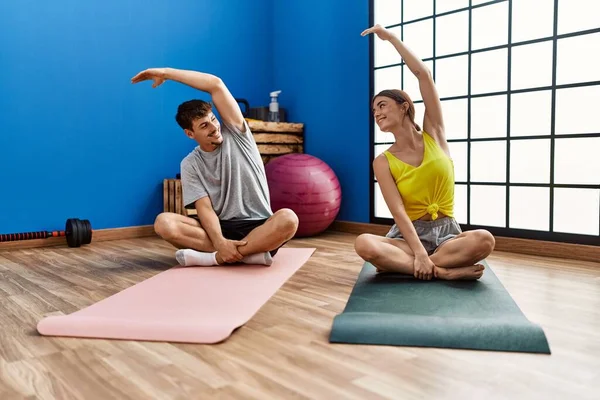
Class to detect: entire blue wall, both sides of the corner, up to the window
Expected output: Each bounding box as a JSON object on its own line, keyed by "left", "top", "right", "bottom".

{"left": 0, "top": 0, "right": 370, "bottom": 233}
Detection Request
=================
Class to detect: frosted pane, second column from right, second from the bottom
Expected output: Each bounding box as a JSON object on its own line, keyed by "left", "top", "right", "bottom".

{"left": 510, "top": 139, "right": 550, "bottom": 183}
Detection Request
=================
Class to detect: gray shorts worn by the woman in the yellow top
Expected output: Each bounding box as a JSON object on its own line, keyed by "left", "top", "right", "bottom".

{"left": 385, "top": 217, "right": 462, "bottom": 255}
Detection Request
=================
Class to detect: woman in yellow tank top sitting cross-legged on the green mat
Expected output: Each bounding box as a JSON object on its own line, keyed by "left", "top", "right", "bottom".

{"left": 355, "top": 25, "right": 495, "bottom": 280}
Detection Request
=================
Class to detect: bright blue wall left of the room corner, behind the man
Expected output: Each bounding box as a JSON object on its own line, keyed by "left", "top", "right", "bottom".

{"left": 0, "top": 0, "right": 273, "bottom": 233}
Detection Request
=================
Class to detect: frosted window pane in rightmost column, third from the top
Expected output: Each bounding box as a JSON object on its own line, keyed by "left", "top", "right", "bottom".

{"left": 556, "top": 86, "right": 600, "bottom": 134}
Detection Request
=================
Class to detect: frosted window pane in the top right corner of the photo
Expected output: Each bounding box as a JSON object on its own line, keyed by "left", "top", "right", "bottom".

{"left": 558, "top": 0, "right": 600, "bottom": 35}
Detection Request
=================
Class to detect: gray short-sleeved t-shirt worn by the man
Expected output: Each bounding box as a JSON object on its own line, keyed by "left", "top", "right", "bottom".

{"left": 181, "top": 121, "right": 273, "bottom": 221}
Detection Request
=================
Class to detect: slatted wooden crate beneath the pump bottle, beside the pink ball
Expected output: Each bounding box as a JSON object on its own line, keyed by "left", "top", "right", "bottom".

{"left": 248, "top": 120, "right": 304, "bottom": 164}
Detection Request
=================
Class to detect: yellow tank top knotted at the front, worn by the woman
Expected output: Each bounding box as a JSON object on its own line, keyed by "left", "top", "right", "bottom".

{"left": 384, "top": 131, "right": 454, "bottom": 221}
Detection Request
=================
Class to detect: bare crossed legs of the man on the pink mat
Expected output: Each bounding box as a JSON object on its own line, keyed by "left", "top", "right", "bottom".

{"left": 154, "top": 209, "right": 298, "bottom": 266}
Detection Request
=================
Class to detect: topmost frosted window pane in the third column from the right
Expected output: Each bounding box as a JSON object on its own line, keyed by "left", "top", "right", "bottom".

{"left": 471, "top": 2, "right": 508, "bottom": 50}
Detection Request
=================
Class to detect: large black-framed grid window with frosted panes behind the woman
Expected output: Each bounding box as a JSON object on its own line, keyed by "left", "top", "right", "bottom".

{"left": 369, "top": 0, "right": 600, "bottom": 245}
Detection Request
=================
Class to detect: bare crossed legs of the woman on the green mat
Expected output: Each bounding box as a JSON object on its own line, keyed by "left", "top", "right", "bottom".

{"left": 354, "top": 229, "right": 495, "bottom": 280}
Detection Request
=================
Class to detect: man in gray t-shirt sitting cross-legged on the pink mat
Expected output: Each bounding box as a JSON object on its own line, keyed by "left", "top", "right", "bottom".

{"left": 131, "top": 68, "right": 298, "bottom": 266}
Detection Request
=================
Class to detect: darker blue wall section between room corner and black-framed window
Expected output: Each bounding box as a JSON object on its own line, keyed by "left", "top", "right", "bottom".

{"left": 273, "top": 0, "right": 371, "bottom": 222}
